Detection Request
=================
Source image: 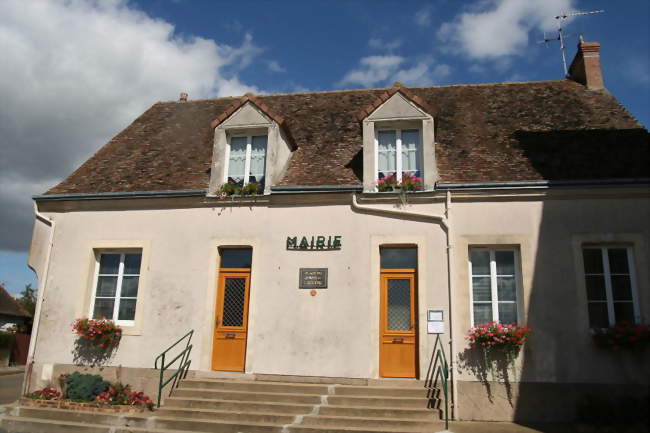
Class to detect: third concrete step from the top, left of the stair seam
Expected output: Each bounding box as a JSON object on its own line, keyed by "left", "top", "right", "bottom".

{"left": 164, "top": 395, "right": 314, "bottom": 415}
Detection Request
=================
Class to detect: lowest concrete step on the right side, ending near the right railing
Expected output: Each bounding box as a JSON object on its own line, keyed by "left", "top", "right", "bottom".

{"left": 299, "top": 415, "right": 436, "bottom": 432}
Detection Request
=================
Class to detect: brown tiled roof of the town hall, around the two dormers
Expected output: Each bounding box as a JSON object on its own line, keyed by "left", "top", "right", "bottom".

{"left": 47, "top": 79, "right": 650, "bottom": 194}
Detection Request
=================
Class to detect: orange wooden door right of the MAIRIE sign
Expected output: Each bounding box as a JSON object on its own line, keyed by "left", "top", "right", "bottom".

{"left": 379, "top": 269, "right": 418, "bottom": 377}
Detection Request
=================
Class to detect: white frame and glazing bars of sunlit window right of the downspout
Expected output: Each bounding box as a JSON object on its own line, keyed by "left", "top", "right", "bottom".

{"left": 467, "top": 246, "right": 522, "bottom": 326}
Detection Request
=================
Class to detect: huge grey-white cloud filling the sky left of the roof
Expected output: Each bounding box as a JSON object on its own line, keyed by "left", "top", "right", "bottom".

{"left": 0, "top": 0, "right": 262, "bottom": 250}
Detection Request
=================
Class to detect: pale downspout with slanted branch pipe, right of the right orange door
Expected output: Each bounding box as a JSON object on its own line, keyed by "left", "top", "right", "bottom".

{"left": 352, "top": 190, "right": 458, "bottom": 419}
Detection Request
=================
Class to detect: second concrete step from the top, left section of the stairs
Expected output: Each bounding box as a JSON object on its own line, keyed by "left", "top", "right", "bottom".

{"left": 172, "top": 385, "right": 321, "bottom": 404}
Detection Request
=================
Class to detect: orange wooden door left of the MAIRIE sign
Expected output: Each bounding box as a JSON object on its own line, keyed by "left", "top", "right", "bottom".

{"left": 212, "top": 269, "right": 250, "bottom": 371}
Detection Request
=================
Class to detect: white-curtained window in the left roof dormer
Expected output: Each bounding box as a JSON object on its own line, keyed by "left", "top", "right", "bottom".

{"left": 225, "top": 135, "right": 267, "bottom": 186}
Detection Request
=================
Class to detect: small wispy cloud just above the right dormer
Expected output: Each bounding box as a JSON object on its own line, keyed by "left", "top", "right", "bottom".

{"left": 336, "top": 55, "right": 451, "bottom": 87}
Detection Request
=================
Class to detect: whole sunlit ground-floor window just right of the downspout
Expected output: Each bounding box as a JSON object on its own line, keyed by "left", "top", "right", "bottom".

{"left": 469, "top": 248, "right": 520, "bottom": 326}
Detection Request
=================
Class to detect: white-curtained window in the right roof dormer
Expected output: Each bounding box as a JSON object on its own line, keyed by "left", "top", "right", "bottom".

{"left": 377, "top": 129, "right": 422, "bottom": 182}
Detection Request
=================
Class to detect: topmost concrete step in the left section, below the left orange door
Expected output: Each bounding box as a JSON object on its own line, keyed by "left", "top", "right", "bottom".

{"left": 182, "top": 379, "right": 328, "bottom": 395}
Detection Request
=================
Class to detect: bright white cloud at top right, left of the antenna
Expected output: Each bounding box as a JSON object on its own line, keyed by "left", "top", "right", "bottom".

{"left": 438, "top": 0, "right": 573, "bottom": 60}
